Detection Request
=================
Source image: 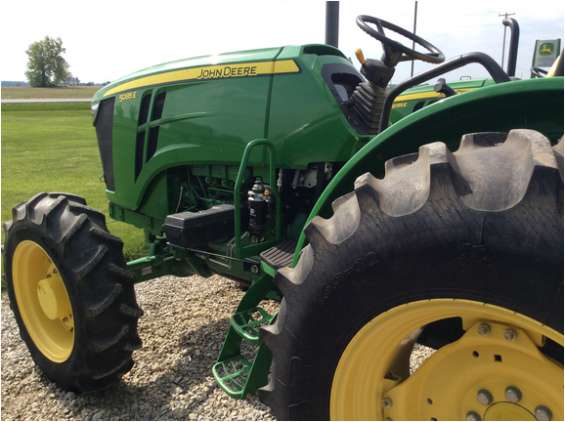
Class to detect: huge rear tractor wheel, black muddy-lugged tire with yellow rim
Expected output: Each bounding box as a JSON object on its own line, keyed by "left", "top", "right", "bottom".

{"left": 260, "top": 130, "right": 563, "bottom": 420}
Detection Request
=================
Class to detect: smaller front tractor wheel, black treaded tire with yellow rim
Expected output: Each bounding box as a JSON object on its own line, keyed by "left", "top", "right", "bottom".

{"left": 4, "top": 193, "right": 142, "bottom": 392}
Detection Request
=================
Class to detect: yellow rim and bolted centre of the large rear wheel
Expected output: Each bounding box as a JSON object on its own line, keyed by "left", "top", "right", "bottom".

{"left": 330, "top": 299, "right": 563, "bottom": 420}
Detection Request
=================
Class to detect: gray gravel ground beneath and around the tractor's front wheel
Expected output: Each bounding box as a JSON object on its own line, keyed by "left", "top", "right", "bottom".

{"left": 1, "top": 276, "right": 273, "bottom": 420}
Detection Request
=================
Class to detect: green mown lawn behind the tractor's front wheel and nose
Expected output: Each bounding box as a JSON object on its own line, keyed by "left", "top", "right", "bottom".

{"left": 2, "top": 103, "right": 143, "bottom": 258}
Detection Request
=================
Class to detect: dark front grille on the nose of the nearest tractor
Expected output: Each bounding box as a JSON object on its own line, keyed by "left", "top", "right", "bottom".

{"left": 95, "top": 97, "right": 114, "bottom": 190}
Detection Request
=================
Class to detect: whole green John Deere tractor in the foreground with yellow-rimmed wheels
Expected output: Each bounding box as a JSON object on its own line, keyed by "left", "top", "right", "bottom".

{"left": 5, "top": 9, "right": 563, "bottom": 420}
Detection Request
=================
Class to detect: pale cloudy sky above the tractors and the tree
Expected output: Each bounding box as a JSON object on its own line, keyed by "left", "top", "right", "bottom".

{"left": 0, "top": 0, "right": 564, "bottom": 82}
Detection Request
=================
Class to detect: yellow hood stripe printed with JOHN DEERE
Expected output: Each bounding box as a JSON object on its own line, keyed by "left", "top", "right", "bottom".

{"left": 104, "top": 59, "right": 300, "bottom": 97}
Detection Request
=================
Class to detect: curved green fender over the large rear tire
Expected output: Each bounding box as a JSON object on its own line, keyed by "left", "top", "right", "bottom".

{"left": 292, "top": 77, "right": 563, "bottom": 266}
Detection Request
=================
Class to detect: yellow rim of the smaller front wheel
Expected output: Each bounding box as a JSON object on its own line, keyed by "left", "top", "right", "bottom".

{"left": 12, "top": 240, "right": 74, "bottom": 363}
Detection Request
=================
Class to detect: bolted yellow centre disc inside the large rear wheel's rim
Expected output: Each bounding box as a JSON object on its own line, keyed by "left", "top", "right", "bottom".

{"left": 384, "top": 321, "right": 560, "bottom": 420}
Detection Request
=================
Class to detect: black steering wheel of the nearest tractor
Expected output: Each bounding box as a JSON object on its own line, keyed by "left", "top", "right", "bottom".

{"left": 357, "top": 15, "right": 445, "bottom": 67}
